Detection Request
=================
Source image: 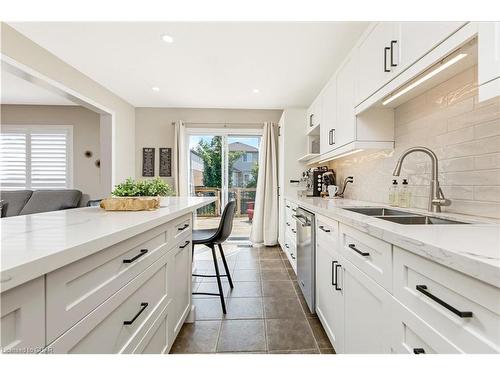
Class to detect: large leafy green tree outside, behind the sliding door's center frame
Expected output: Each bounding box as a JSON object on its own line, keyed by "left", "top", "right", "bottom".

{"left": 195, "top": 136, "right": 243, "bottom": 188}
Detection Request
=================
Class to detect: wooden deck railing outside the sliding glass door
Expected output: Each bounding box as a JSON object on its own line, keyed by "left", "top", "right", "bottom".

{"left": 194, "top": 186, "right": 256, "bottom": 216}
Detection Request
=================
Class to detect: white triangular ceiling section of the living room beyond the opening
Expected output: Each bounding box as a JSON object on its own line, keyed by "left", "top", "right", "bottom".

{"left": 1, "top": 66, "right": 77, "bottom": 105}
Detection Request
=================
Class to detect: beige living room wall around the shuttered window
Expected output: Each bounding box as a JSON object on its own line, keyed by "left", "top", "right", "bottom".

{"left": 1, "top": 104, "right": 102, "bottom": 199}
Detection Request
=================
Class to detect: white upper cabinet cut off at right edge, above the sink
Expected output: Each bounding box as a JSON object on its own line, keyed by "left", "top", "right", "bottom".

{"left": 478, "top": 22, "right": 500, "bottom": 101}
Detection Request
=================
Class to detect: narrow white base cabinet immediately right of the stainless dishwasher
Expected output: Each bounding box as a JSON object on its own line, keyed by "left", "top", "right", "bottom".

{"left": 316, "top": 217, "right": 344, "bottom": 353}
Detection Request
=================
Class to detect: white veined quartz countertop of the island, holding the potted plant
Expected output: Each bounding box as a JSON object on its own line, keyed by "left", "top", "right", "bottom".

{"left": 0, "top": 197, "right": 215, "bottom": 291}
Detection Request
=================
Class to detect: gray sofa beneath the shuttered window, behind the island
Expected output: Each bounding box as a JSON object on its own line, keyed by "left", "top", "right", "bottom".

{"left": 0, "top": 189, "right": 82, "bottom": 217}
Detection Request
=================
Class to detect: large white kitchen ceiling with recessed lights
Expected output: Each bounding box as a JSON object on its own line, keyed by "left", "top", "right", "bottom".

{"left": 6, "top": 22, "right": 368, "bottom": 109}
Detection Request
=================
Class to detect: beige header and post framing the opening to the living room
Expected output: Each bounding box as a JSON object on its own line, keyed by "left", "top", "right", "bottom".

{"left": 1, "top": 23, "right": 135, "bottom": 190}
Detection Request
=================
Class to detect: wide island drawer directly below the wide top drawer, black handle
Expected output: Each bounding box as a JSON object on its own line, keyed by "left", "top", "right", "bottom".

{"left": 48, "top": 252, "right": 171, "bottom": 353}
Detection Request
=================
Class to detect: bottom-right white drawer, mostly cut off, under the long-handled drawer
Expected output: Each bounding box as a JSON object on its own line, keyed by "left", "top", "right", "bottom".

{"left": 391, "top": 301, "right": 460, "bottom": 354}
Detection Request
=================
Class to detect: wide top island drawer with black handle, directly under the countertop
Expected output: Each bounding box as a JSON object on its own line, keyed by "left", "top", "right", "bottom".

{"left": 46, "top": 226, "right": 168, "bottom": 344}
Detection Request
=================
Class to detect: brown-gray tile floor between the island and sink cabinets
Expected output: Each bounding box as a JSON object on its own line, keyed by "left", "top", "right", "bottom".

{"left": 171, "top": 243, "right": 335, "bottom": 354}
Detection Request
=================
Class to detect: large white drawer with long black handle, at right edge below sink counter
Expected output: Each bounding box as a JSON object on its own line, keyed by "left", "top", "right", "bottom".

{"left": 394, "top": 247, "right": 500, "bottom": 353}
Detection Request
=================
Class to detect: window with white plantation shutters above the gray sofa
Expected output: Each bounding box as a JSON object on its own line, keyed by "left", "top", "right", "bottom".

{"left": 0, "top": 125, "right": 73, "bottom": 190}
